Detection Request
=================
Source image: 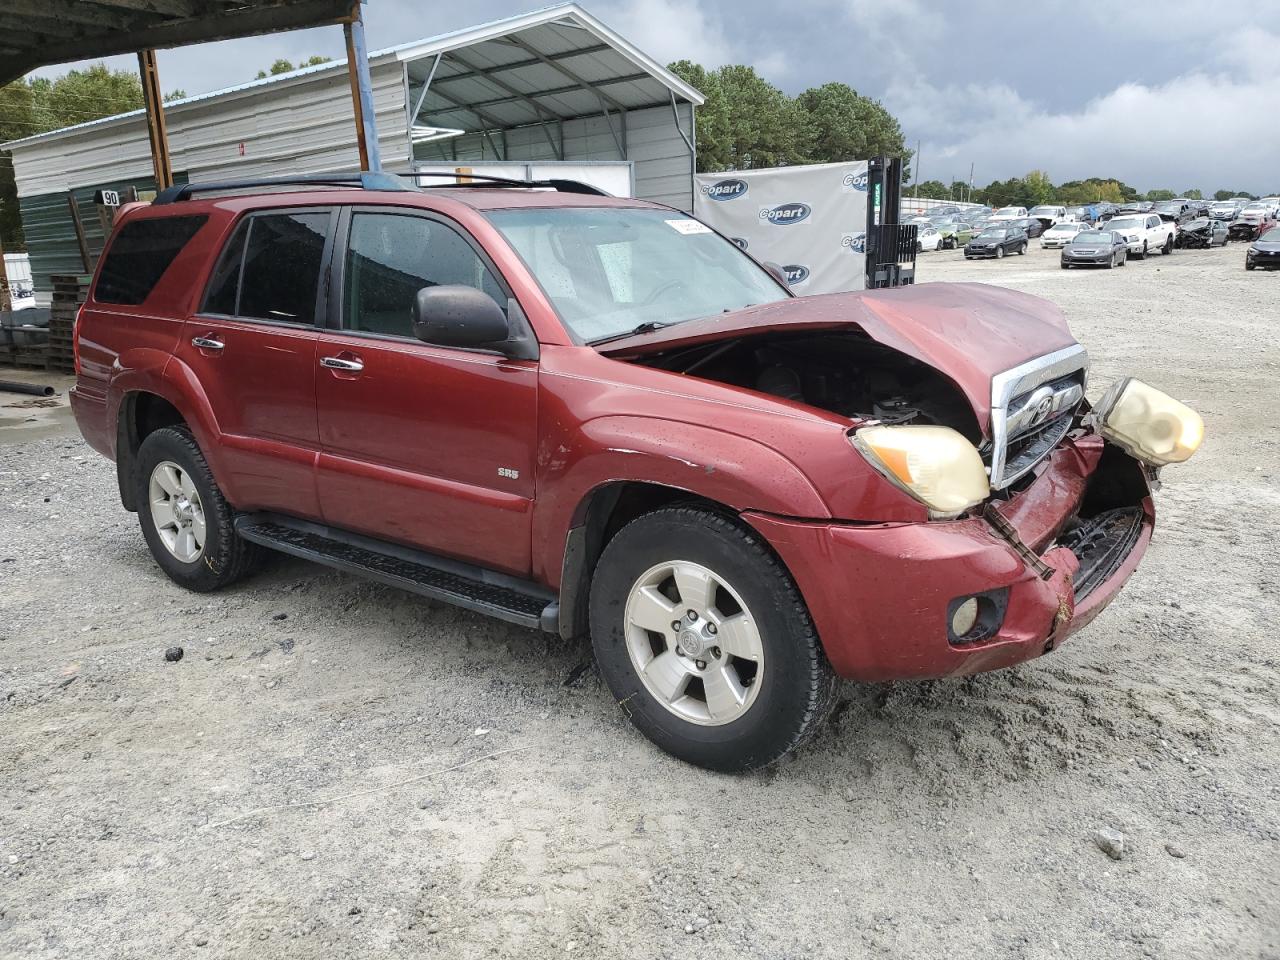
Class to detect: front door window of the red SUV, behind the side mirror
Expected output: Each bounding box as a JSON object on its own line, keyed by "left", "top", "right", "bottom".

{"left": 343, "top": 214, "right": 507, "bottom": 337}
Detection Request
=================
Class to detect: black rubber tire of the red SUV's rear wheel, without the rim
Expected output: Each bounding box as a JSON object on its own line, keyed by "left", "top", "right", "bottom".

{"left": 136, "top": 426, "right": 259, "bottom": 593}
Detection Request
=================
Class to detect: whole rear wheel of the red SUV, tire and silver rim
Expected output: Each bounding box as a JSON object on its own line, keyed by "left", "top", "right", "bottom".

{"left": 136, "top": 426, "right": 257, "bottom": 593}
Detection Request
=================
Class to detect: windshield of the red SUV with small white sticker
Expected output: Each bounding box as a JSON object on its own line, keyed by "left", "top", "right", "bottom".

{"left": 489, "top": 207, "right": 787, "bottom": 342}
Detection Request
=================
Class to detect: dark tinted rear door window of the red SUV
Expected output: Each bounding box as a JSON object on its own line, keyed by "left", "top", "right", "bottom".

{"left": 204, "top": 212, "right": 330, "bottom": 324}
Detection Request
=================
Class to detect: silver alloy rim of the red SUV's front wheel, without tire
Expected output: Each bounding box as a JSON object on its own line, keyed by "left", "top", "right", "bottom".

{"left": 623, "top": 561, "right": 764, "bottom": 727}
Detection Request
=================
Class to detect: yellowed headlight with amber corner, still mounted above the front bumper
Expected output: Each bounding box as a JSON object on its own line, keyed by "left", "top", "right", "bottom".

{"left": 852, "top": 426, "right": 991, "bottom": 520}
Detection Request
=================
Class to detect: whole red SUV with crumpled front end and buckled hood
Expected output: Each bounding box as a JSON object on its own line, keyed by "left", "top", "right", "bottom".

{"left": 72, "top": 175, "right": 1202, "bottom": 771}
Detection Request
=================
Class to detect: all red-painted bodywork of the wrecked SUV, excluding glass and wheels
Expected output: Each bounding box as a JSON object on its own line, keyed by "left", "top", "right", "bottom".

{"left": 72, "top": 189, "right": 1172, "bottom": 680}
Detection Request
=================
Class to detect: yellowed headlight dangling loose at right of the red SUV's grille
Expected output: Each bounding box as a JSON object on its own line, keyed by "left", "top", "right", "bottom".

{"left": 1093, "top": 376, "right": 1204, "bottom": 467}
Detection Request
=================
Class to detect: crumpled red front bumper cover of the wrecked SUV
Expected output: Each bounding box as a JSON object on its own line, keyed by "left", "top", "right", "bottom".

{"left": 745, "top": 436, "right": 1155, "bottom": 681}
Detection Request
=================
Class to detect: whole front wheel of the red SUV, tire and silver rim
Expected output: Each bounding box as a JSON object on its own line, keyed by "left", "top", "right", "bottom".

{"left": 590, "top": 507, "right": 836, "bottom": 772}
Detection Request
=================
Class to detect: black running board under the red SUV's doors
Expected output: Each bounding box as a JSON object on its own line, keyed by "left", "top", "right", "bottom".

{"left": 236, "top": 513, "right": 559, "bottom": 634}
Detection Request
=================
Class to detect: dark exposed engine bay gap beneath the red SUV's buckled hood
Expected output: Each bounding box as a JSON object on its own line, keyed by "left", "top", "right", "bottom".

{"left": 635, "top": 332, "right": 982, "bottom": 444}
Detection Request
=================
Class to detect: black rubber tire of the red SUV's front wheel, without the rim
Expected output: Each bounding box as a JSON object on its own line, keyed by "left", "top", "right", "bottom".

{"left": 590, "top": 507, "right": 837, "bottom": 772}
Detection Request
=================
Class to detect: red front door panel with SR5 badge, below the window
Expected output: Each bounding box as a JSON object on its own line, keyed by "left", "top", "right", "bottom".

{"left": 315, "top": 332, "right": 538, "bottom": 576}
